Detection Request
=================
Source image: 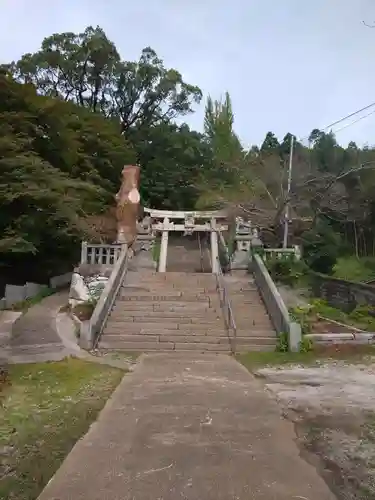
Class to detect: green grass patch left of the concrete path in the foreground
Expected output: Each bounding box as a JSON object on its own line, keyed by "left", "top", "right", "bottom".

{"left": 0, "top": 359, "right": 124, "bottom": 500}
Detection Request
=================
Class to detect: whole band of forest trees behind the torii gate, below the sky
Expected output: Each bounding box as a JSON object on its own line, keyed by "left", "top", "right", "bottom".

{"left": 0, "top": 27, "right": 375, "bottom": 281}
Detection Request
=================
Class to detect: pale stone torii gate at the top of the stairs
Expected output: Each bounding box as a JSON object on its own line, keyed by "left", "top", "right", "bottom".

{"left": 144, "top": 208, "right": 228, "bottom": 274}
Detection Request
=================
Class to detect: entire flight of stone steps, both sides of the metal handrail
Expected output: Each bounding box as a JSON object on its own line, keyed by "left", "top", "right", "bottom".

{"left": 99, "top": 268, "right": 276, "bottom": 353}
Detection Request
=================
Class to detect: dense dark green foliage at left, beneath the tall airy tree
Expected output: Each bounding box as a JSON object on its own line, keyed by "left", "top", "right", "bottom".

{"left": 0, "top": 75, "right": 134, "bottom": 276}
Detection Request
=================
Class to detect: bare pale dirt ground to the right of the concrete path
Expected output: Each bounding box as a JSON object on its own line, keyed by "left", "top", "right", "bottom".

{"left": 257, "top": 361, "right": 375, "bottom": 500}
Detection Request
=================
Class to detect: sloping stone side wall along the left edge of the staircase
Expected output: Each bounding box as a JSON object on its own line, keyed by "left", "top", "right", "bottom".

{"left": 80, "top": 245, "right": 133, "bottom": 349}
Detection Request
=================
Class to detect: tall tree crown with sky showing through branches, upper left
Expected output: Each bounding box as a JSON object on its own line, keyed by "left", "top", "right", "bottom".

{"left": 3, "top": 26, "right": 202, "bottom": 132}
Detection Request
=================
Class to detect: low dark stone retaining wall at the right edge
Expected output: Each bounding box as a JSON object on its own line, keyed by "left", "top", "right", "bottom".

{"left": 312, "top": 274, "right": 375, "bottom": 312}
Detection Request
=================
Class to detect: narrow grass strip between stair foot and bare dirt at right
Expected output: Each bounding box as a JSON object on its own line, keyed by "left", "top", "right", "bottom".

{"left": 236, "top": 345, "right": 375, "bottom": 371}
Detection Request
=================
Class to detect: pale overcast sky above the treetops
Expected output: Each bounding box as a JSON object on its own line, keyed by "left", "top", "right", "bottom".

{"left": 0, "top": 0, "right": 375, "bottom": 146}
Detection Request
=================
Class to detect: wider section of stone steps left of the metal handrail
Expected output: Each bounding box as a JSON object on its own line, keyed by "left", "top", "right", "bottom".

{"left": 99, "top": 270, "right": 230, "bottom": 352}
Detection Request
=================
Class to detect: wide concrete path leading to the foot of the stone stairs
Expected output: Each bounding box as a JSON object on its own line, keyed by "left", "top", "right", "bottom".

{"left": 39, "top": 354, "right": 335, "bottom": 500}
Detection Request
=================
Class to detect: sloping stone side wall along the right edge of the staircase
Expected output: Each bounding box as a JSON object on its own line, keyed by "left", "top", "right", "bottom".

{"left": 252, "top": 254, "right": 302, "bottom": 352}
